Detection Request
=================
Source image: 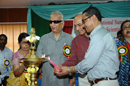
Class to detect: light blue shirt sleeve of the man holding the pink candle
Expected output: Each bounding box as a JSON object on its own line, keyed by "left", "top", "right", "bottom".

{"left": 75, "top": 35, "right": 106, "bottom": 74}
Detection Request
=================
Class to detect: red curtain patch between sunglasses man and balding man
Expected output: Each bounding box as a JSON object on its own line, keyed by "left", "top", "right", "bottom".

{"left": 63, "top": 20, "right": 73, "bottom": 34}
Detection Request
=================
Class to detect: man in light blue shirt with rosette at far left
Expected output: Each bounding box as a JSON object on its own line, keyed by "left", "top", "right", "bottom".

{"left": 0, "top": 34, "right": 13, "bottom": 86}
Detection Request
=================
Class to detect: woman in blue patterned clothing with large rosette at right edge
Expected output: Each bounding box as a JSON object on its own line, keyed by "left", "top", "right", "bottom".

{"left": 116, "top": 20, "right": 130, "bottom": 86}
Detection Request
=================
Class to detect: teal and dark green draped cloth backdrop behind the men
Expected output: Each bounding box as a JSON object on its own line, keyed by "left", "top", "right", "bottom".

{"left": 27, "top": 1, "right": 130, "bottom": 39}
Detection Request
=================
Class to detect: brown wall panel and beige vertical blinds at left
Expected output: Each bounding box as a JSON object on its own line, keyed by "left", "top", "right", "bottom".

{"left": 0, "top": 8, "right": 28, "bottom": 52}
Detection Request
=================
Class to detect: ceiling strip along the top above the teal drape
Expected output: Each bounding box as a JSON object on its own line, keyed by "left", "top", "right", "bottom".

{"left": 0, "top": 0, "right": 130, "bottom": 8}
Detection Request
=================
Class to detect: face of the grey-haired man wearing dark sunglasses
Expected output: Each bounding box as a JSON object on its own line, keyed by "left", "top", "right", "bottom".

{"left": 50, "top": 14, "right": 64, "bottom": 33}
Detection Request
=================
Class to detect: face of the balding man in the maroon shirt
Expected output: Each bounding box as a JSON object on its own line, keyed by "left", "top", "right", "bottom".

{"left": 74, "top": 14, "right": 86, "bottom": 35}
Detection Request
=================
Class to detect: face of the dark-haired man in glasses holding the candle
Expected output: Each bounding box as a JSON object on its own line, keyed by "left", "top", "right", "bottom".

{"left": 82, "top": 13, "right": 94, "bottom": 33}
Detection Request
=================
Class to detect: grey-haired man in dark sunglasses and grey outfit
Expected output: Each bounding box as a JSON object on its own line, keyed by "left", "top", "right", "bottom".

{"left": 36, "top": 12, "right": 73, "bottom": 86}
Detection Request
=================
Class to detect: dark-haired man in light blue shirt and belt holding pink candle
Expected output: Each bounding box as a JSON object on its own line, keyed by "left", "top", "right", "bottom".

{"left": 54, "top": 7, "right": 119, "bottom": 86}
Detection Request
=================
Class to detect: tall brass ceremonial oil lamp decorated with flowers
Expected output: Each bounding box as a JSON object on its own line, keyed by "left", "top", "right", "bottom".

{"left": 21, "top": 28, "right": 45, "bottom": 86}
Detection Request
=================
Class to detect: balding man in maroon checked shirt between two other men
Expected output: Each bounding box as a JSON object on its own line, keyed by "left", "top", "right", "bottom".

{"left": 62, "top": 14, "right": 90, "bottom": 86}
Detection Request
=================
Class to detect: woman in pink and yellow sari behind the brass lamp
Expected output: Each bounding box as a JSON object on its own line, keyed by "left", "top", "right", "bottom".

{"left": 7, "top": 33, "right": 30, "bottom": 86}
